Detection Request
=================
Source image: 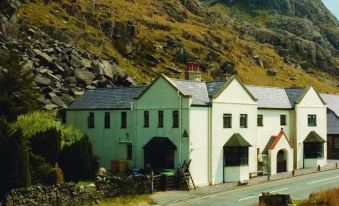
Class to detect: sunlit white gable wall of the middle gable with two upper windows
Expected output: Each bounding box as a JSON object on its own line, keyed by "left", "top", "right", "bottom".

{"left": 211, "top": 80, "right": 257, "bottom": 184}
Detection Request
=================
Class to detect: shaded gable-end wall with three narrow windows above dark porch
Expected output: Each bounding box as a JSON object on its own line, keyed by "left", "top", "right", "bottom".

{"left": 134, "top": 78, "right": 190, "bottom": 171}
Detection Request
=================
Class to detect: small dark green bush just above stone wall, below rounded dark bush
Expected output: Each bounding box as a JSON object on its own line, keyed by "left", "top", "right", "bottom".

{"left": 29, "top": 152, "right": 52, "bottom": 185}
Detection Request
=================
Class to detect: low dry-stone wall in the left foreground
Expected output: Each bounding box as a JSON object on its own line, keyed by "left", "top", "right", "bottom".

{"left": 6, "top": 175, "right": 151, "bottom": 206}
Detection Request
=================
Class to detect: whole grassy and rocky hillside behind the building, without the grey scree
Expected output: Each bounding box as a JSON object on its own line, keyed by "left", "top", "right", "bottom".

{"left": 1, "top": 0, "right": 339, "bottom": 92}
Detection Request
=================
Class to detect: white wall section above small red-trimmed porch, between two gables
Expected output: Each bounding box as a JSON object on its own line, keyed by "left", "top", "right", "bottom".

{"left": 257, "top": 109, "right": 293, "bottom": 153}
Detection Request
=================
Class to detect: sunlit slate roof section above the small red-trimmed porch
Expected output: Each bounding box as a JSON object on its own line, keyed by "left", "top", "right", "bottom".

{"left": 246, "top": 86, "right": 292, "bottom": 109}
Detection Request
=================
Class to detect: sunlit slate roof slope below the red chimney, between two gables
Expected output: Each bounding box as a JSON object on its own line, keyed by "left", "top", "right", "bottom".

{"left": 168, "top": 78, "right": 210, "bottom": 106}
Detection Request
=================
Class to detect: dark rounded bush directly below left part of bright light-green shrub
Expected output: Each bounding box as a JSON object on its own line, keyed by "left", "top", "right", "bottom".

{"left": 31, "top": 128, "right": 61, "bottom": 165}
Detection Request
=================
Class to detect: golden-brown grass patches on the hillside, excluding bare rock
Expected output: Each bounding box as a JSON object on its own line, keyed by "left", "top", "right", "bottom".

{"left": 18, "top": 0, "right": 339, "bottom": 92}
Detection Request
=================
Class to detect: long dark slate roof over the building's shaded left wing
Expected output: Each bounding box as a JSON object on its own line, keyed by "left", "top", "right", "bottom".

{"left": 68, "top": 86, "right": 147, "bottom": 110}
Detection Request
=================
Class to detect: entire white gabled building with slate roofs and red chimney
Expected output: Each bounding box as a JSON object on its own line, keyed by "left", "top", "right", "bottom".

{"left": 66, "top": 70, "right": 327, "bottom": 185}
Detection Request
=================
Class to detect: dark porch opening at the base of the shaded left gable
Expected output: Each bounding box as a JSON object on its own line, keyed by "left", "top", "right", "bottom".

{"left": 144, "top": 137, "right": 177, "bottom": 170}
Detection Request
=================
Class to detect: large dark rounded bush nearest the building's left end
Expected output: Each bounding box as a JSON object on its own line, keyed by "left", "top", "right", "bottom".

{"left": 59, "top": 135, "right": 99, "bottom": 182}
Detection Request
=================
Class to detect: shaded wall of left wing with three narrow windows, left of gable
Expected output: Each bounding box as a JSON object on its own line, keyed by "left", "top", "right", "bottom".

{"left": 66, "top": 110, "right": 135, "bottom": 169}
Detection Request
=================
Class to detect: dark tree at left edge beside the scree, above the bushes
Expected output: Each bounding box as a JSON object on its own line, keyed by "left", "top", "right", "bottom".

{"left": 0, "top": 50, "right": 38, "bottom": 121}
